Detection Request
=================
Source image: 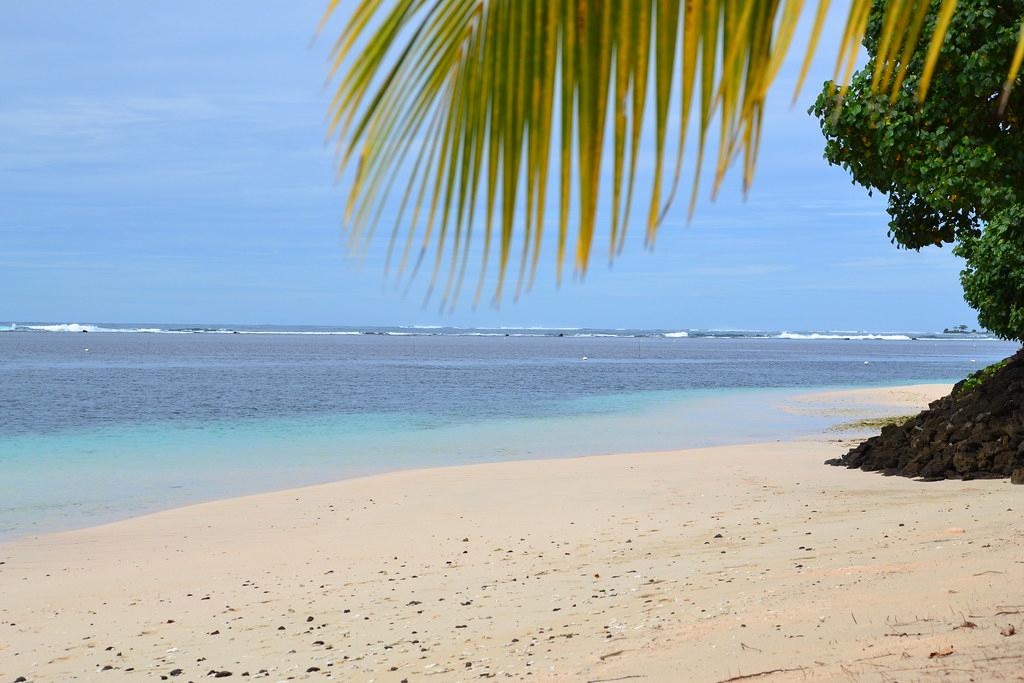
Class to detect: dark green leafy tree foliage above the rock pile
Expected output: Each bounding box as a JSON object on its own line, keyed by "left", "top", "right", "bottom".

{"left": 811, "top": 0, "right": 1024, "bottom": 340}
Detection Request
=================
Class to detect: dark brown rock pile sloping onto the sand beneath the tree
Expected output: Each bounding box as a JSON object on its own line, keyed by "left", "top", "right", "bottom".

{"left": 825, "top": 349, "right": 1024, "bottom": 483}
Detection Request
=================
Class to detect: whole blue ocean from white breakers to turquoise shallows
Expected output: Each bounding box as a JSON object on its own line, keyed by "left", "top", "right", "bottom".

{"left": 0, "top": 323, "right": 1017, "bottom": 539}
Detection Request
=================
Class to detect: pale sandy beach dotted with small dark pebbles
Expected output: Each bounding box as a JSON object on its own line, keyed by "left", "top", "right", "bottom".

{"left": 0, "top": 385, "right": 1024, "bottom": 683}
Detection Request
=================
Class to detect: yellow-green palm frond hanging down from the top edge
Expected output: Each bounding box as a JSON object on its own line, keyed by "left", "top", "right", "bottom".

{"left": 321, "top": 0, "right": 1024, "bottom": 305}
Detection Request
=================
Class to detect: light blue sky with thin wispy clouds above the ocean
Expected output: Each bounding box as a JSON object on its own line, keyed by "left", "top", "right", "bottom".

{"left": 0, "top": 0, "right": 976, "bottom": 331}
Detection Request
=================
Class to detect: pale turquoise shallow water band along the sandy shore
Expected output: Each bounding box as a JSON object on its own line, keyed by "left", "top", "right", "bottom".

{"left": 0, "top": 389, "right": 835, "bottom": 538}
